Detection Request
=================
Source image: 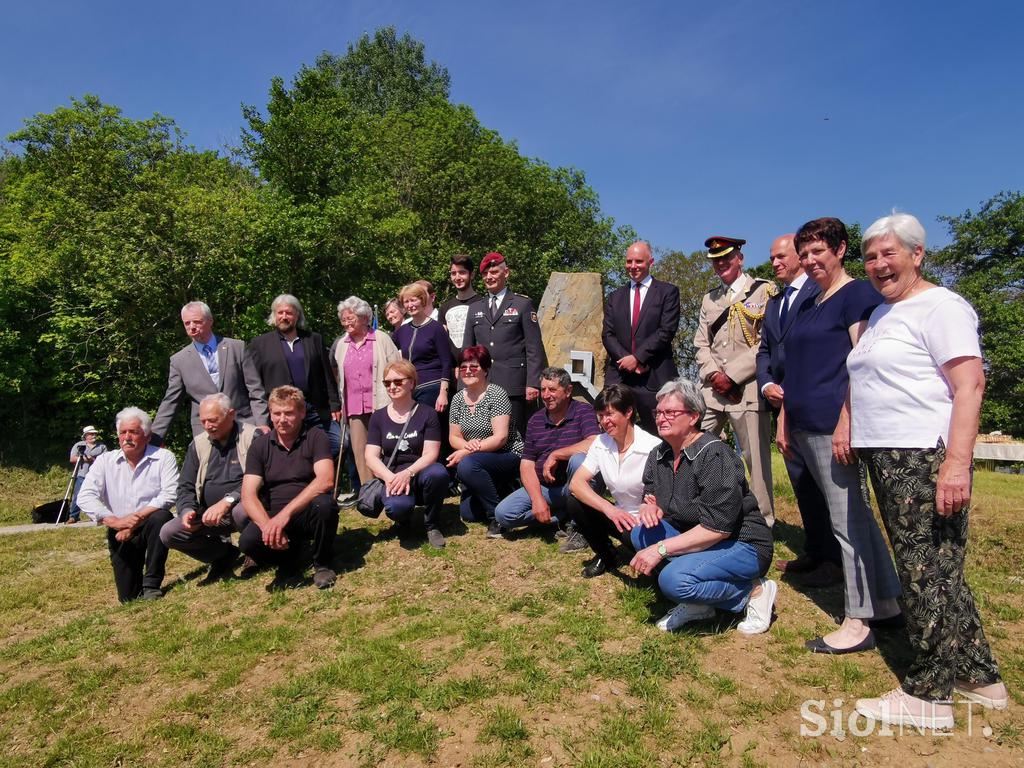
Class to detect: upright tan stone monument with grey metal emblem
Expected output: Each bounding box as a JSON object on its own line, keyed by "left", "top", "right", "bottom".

{"left": 537, "top": 272, "right": 608, "bottom": 401}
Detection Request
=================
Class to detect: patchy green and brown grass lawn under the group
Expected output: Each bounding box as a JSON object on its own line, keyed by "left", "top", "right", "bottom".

{"left": 0, "top": 464, "right": 1024, "bottom": 768}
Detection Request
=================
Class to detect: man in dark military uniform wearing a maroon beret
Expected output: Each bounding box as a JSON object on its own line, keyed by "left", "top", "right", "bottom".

{"left": 466, "top": 253, "right": 548, "bottom": 434}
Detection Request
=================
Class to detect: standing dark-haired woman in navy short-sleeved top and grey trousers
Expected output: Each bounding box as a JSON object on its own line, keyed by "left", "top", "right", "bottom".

{"left": 776, "top": 218, "right": 900, "bottom": 653}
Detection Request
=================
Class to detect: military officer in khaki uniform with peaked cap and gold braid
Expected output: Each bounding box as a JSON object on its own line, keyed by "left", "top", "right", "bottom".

{"left": 693, "top": 237, "right": 778, "bottom": 525}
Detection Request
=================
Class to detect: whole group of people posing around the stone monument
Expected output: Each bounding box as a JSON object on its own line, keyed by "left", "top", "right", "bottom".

{"left": 70, "top": 214, "right": 1007, "bottom": 728}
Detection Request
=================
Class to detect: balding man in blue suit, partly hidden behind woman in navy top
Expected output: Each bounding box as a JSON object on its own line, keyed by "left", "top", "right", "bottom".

{"left": 757, "top": 234, "right": 843, "bottom": 587}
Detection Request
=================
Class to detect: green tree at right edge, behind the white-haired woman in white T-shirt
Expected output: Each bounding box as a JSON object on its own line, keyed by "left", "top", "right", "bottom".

{"left": 933, "top": 191, "right": 1024, "bottom": 436}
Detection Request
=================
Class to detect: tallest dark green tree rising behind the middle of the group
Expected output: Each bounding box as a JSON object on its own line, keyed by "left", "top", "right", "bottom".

{"left": 244, "top": 30, "right": 632, "bottom": 317}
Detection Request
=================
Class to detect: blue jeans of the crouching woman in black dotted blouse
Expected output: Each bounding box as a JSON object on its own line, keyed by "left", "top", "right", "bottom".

{"left": 630, "top": 520, "right": 762, "bottom": 613}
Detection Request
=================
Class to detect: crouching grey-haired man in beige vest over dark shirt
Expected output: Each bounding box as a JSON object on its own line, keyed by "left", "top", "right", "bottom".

{"left": 160, "top": 392, "right": 258, "bottom": 582}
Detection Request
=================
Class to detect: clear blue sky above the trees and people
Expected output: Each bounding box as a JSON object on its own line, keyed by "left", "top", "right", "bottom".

{"left": 0, "top": 0, "right": 1024, "bottom": 264}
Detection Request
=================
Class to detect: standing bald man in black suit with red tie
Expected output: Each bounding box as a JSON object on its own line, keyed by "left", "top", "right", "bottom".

{"left": 601, "top": 241, "right": 679, "bottom": 435}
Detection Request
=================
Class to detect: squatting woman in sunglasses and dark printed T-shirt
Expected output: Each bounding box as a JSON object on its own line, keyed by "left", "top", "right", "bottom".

{"left": 366, "top": 360, "right": 449, "bottom": 549}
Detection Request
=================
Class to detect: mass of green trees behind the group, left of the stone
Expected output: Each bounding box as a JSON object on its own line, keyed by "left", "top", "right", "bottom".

{"left": 0, "top": 29, "right": 631, "bottom": 456}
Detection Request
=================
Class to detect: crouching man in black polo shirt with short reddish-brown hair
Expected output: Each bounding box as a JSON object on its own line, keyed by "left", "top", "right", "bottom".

{"left": 239, "top": 385, "right": 338, "bottom": 590}
